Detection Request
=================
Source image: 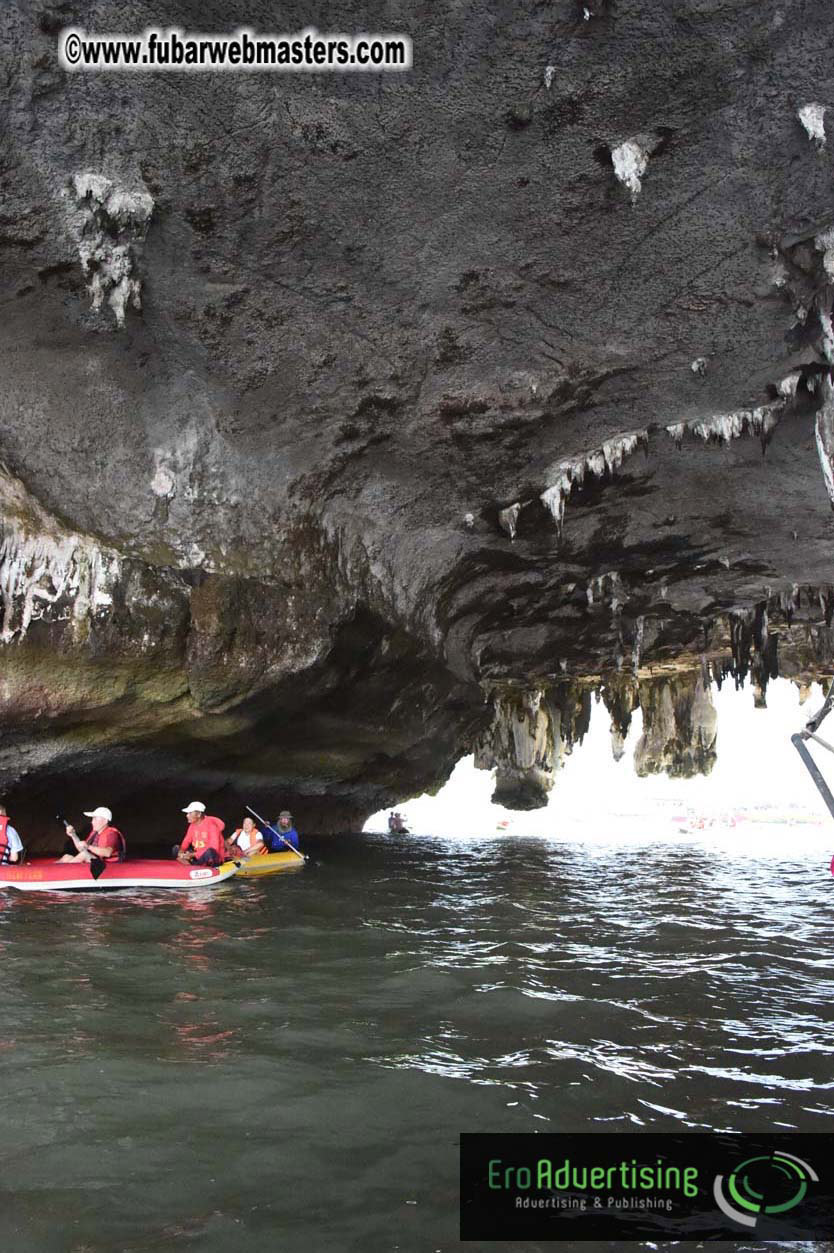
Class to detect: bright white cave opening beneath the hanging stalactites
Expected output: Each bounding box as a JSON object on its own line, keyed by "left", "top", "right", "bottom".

{"left": 364, "top": 679, "right": 830, "bottom": 853}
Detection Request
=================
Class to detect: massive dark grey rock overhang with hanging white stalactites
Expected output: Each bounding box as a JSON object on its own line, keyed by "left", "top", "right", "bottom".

{"left": 0, "top": 0, "right": 834, "bottom": 842}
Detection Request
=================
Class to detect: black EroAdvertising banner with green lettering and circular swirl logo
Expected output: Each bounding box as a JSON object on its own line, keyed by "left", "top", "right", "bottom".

{"left": 461, "top": 1133, "right": 834, "bottom": 1240}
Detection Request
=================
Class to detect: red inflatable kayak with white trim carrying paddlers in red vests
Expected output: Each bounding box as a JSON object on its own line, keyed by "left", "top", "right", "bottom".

{"left": 0, "top": 857, "right": 238, "bottom": 892}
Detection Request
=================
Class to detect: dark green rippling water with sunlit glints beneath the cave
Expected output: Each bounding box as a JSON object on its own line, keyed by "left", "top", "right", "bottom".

{"left": 0, "top": 833, "right": 834, "bottom": 1253}
